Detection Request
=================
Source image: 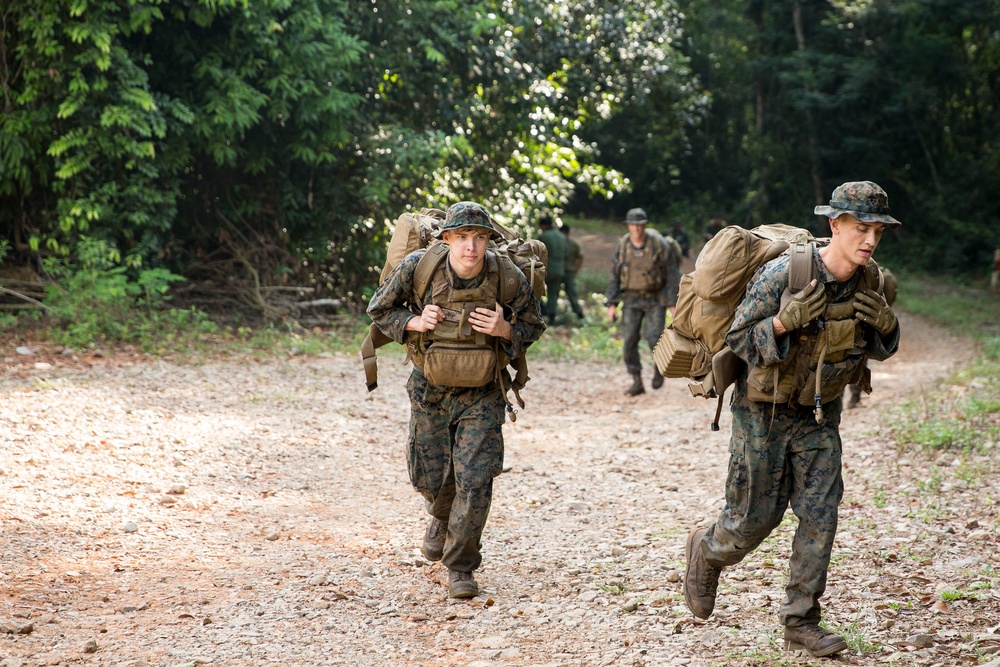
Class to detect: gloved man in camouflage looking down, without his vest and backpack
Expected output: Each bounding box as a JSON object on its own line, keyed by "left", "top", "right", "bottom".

{"left": 684, "top": 181, "right": 900, "bottom": 657}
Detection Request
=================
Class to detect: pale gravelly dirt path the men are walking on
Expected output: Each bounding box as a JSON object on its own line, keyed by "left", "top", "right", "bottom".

{"left": 0, "top": 302, "right": 1000, "bottom": 667}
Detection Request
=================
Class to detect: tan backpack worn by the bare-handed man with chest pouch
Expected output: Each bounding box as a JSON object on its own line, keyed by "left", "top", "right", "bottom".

{"left": 361, "top": 209, "right": 548, "bottom": 421}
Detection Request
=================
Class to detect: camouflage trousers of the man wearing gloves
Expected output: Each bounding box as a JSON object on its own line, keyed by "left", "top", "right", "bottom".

{"left": 701, "top": 379, "right": 844, "bottom": 626}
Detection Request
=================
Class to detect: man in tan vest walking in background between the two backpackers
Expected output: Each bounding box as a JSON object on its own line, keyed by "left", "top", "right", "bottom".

{"left": 604, "top": 208, "right": 680, "bottom": 396}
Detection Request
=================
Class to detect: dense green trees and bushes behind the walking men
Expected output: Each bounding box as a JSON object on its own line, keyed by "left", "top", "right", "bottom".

{"left": 0, "top": 0, "right": 1000, "bottom": 338}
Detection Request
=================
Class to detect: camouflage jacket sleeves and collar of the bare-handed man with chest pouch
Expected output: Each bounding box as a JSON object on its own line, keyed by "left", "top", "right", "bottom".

{"left": 368, "top": 249, "right": 545, "bottom": 366}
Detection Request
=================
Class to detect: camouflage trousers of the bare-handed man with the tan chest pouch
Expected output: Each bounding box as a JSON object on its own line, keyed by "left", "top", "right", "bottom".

{"left": 406, "top": 368, "right": 505, "bottom": 572}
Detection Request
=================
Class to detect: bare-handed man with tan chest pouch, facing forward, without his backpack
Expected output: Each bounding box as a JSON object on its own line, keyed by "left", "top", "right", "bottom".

{"left": 368, "top": 202, "right": 545, "bottom": 598}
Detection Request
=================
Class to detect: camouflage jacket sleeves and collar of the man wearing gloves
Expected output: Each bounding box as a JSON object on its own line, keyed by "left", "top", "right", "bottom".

{"left": 726, "top": 250, "right": 899, "bottom": 388}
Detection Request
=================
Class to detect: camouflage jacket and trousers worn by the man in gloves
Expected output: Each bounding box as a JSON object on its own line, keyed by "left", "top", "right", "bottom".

{"left": 701, "top": 245, "right": 899, "bottom": 626}
